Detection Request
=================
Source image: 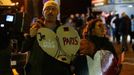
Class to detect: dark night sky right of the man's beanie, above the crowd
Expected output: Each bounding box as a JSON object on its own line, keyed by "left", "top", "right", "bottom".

{"left": 60, "top": 0, "right": 90, "bottom": 22}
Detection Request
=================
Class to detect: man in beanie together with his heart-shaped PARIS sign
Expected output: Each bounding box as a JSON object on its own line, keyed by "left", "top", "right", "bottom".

{"left": 23, "top": 1, "right": 80, "bottom": 75}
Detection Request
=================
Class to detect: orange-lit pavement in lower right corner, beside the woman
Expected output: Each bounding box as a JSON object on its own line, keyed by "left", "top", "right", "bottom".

{"left": 113, "top": 43, "right": 134, "bottom": 75}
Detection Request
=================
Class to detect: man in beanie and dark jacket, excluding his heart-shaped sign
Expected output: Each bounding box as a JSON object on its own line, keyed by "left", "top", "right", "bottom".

{"left": 25, "top": 1, "right": 71, "bottom": 75}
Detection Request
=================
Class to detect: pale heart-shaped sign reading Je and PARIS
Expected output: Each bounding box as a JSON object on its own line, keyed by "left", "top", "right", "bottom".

{"left": 37, "top": 26, "right": 80, "bottom": 64}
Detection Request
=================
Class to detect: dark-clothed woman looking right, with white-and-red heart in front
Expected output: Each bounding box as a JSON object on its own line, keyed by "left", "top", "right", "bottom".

{"left": 74, "top": 19, "right": 119, "bottom": 75}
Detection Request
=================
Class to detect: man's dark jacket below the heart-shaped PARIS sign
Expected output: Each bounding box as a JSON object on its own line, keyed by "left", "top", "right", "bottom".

{"left": 26, "top": 41, "right": 71, "bottom": 75}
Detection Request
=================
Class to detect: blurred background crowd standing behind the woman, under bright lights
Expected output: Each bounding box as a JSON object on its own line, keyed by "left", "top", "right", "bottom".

{"left": 65, "top": 12, "right": 134, "bottom": 51}
